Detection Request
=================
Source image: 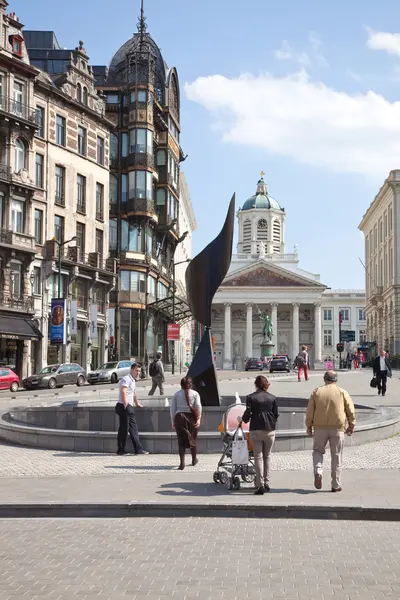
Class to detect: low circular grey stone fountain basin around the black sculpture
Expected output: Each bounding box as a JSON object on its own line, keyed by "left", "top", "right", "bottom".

{"left": 0, "top": 396, "right": 400, "bottom": 454}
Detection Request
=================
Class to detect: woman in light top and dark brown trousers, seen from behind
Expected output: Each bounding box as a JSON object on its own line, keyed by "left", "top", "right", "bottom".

{"left": 170, "top": 377, "right": 202, "bottom": 471}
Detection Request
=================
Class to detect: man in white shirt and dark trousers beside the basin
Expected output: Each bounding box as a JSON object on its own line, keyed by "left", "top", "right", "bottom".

{"left": 115, "top": 363, "right": 148, "bottom": 456}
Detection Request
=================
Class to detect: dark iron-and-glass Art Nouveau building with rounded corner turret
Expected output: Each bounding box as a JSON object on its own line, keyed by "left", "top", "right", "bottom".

{"left": 94, "top": 8, "right": 187, "bottom": 362}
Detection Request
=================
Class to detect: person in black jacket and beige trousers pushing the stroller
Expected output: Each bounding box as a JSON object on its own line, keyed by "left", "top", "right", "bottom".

{"left": 242, "top": 375, "right": 279, "bottom": 495}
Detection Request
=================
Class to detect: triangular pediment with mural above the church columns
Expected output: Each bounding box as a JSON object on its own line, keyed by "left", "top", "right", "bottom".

{"left": 221, "top": 266, "right": 325, "bottom": 289}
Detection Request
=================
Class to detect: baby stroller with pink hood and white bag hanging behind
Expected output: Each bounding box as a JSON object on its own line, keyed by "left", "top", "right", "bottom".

{"left": 213, "top": 404, "right": 256, "bottom": 490}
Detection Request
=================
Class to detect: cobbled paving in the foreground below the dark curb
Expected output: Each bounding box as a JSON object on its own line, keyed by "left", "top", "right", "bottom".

{"left": 0, "top": 518, "right": 400, "bottom": 600}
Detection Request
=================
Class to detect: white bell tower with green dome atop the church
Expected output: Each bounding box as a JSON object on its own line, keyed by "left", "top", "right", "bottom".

{"left": 237, "top": 173, "right": 286, "bottom": 257}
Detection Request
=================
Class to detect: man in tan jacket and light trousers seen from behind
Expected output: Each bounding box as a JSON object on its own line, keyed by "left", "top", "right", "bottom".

{"left": 306, "top": 371, "right": 355, "bottom": 492}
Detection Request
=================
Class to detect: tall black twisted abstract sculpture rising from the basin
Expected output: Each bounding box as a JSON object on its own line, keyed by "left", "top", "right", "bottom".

{"left": 186, "top": 194, "right": 235, "bottom": 406}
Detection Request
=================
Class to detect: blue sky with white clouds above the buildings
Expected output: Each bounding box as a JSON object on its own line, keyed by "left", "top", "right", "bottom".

{"left": 9, "top": 0, "right": 400, "bottom": 288}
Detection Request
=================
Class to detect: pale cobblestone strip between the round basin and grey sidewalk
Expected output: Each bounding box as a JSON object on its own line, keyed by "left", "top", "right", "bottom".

{"left": 0, "top": 435, "right": 400, "bottom": 478}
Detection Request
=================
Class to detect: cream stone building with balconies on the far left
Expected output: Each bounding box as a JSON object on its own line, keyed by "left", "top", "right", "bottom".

{"left": 0, "top": 0, "right": 116, "bottom": 377}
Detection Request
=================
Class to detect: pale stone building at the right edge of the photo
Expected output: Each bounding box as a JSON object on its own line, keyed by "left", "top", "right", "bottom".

{"left": 359, "top": 170, "right": 400, "bottom": 356}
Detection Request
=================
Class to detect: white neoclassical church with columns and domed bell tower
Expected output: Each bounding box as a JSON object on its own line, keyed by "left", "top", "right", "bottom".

{"left": 212, "top": 173, "right": 365, "bottom": 369}
